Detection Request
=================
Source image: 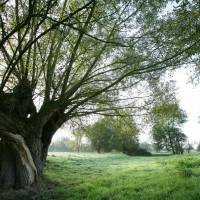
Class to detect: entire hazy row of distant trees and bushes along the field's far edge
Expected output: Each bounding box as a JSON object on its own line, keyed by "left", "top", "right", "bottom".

{"left": 50, "top": 101, "right": 194, "bottom": 155}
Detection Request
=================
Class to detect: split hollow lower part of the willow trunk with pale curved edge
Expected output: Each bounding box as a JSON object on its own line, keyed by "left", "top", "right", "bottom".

{"left": 0, "top": 131, "right": 38, "bottom": 188}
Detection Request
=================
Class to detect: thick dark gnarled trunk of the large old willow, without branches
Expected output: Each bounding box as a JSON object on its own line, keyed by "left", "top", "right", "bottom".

{"left": 0, "top": 88, "right": 64, "bottom": 188}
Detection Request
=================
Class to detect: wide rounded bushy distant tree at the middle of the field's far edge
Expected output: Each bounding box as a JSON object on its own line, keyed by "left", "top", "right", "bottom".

{"left": 81, "top": 117, "right": 139, "bottom": 153}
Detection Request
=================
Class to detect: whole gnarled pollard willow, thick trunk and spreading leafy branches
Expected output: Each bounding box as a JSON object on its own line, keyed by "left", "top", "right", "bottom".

{"left": 0, "top": 0, "right": 196, "bottom": 188}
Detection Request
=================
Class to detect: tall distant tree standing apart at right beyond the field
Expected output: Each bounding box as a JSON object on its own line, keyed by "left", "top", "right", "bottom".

{"left": 151, "top": 102, "right": 187, "bottom": 154}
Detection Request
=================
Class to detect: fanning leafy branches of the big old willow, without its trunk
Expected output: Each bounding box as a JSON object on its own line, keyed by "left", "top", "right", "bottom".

{"left": 0, "top": 0, "right": 198, "bottom": 121}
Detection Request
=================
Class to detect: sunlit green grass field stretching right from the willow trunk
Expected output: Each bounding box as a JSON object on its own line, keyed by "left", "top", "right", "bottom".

{"left": 40, "top": 153, "right": 200, "bottom": 200}
